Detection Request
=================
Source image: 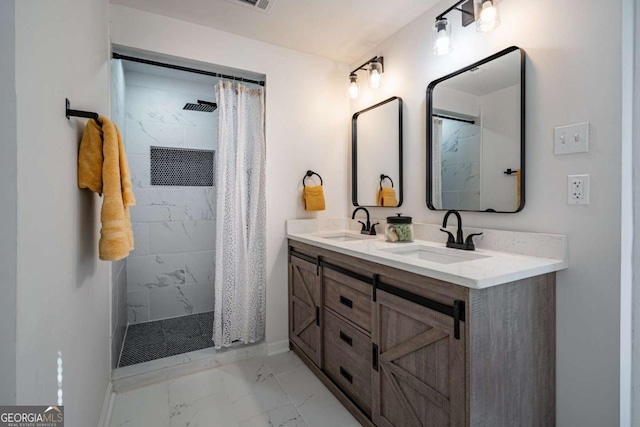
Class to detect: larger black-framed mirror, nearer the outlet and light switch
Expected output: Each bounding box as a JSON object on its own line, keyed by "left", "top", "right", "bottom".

{"left": 427, "top": 46, "right": 525, "bottom": 213}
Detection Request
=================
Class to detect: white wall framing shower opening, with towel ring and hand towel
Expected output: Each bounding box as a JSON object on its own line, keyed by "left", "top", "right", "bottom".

{"left": 111, "top": 5, "right": 350, "bottom": 343}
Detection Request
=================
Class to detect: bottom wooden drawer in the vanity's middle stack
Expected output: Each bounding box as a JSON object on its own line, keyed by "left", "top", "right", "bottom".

{"left": 323, "top": 328, "right": 372, "bottom": 415}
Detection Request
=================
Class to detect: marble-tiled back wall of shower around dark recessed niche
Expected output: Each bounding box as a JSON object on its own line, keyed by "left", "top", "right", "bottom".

{"left": 125, "top": 73, "right": 217, "bottom": 323}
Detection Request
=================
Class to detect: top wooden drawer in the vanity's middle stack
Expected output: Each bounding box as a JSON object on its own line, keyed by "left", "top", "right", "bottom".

{"left": 322, "top": 269, "right": 372, "bottom": 332}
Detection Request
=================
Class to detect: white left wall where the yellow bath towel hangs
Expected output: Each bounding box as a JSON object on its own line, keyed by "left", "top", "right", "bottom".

{"left": 14, "top": 0, "right": 111, "bottom": 427}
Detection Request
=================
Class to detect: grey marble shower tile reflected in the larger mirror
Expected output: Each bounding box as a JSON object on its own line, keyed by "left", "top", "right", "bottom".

{"left": 441, "top": 119, "right": 482, "bottom": 210}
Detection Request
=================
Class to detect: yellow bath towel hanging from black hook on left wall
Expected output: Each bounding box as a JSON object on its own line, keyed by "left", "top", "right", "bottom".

{"left": 78, "top": 116, "right": 136, "bottom": 261}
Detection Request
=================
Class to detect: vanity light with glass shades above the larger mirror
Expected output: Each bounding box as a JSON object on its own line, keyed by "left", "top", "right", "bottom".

{"left": 433, "top": 0, "right": 500, "bottom": 55}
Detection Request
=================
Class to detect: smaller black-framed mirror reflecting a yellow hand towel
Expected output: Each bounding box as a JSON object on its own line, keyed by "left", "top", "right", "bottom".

{"left": 351, "top": 96, "right": 403, "bottom": 207}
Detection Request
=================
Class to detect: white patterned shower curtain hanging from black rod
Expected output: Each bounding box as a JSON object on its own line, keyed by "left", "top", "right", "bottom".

{"left": 213, "top": 81, "right": 266, "bottom": 348}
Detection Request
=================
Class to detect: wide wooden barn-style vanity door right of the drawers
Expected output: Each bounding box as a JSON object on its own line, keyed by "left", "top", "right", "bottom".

{"left": 372, "top": 290, "right": 466, "bottom": 427}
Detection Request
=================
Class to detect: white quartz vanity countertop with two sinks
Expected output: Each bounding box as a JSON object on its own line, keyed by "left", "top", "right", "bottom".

{"left": 287, "top": 222, "right": 568, "bottom": 289}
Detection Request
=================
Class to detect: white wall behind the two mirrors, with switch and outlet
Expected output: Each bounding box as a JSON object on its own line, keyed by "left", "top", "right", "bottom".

{"left": 352, "top": 0, "right": 621, "bottom": 427}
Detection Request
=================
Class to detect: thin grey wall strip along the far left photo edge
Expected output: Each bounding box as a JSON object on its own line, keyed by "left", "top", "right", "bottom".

{"left": 0, "top": 0, "right": 18, "bottom": 405}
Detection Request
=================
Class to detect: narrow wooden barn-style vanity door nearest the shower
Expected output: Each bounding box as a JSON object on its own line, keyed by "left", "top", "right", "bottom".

{"left": 289, "top": 257, "right": 322, "bottom": 366}
